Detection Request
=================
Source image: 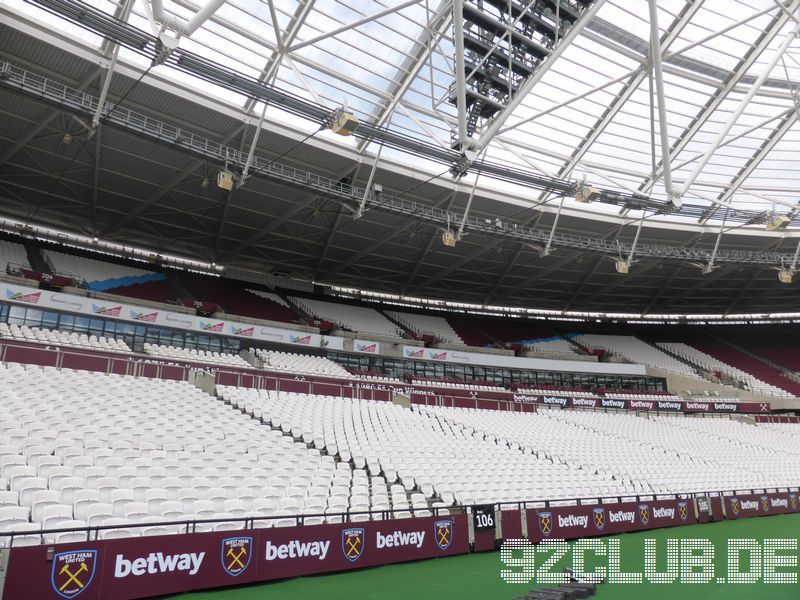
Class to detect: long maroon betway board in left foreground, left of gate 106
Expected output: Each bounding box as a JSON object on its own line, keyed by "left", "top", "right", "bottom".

{"left": 3, "top": 515, "right": 469, "bottom": 600}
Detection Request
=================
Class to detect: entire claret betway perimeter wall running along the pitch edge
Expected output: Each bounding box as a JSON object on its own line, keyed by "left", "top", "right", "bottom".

{"left": 0, "top": 489, "right": 800, "bottom": 600}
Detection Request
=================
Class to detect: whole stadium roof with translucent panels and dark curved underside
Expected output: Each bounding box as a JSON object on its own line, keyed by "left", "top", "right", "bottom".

{"left": 0, "top": 0, "right": 800, "bottom": 313}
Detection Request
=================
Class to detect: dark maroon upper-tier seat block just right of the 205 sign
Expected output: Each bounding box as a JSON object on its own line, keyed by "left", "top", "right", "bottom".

{"left": 181, "top": 275, "right": 298, "bottom": 323}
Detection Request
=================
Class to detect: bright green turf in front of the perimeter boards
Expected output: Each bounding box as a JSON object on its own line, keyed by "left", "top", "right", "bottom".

{"left": 164, "top": 514, "right": 800, "bottom": 600}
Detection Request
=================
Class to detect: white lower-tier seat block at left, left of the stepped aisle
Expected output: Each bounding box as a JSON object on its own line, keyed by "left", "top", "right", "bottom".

{"left": 0, "top": 364, "right": 354, "bottom": 545}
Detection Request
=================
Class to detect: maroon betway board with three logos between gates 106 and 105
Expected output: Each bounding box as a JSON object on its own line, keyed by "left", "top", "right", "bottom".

{"left": 527, "top": 500, "right": 696, "bottom": 542}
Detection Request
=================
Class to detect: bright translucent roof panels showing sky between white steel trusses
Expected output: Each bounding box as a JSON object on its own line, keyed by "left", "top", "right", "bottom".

{"left": 10, "top": 0, "right": 800, "bottom": 221}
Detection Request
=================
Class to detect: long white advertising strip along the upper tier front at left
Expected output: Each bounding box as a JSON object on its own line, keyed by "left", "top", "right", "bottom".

{"left": 0, "top": 283, "right": 334, "bottom": 350}
